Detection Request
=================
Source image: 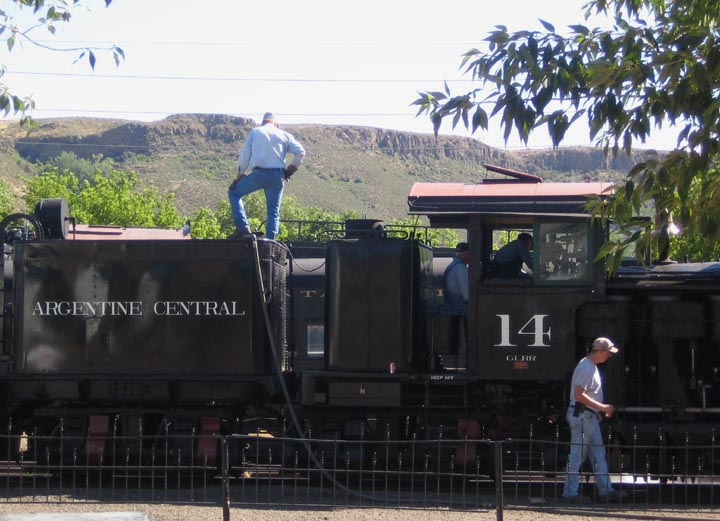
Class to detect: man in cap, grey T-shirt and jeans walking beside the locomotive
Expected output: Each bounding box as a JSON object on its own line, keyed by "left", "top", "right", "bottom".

{"left": 563, "top": 337, "right": 627, "bottom": 502}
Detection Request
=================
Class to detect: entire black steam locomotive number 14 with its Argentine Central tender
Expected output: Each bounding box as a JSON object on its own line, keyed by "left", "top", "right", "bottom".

{"left": 0, "top": 167, "right": 720, "bottom": 473}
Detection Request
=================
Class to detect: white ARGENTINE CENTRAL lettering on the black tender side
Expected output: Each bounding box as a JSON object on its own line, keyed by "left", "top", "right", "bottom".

{"left": 33, "top": 300, "right": 245, "bottom": 317}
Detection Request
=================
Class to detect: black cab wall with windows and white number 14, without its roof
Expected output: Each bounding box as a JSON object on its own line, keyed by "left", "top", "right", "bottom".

{"left": 469, "top": 214, "right": 604, "bottom": 381}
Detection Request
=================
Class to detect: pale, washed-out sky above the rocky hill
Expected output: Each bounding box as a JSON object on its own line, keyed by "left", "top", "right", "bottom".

{"left": 0, "top": 0, "right": 673, "bottom": 148}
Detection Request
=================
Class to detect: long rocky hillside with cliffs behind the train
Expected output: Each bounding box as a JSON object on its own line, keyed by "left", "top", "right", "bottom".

{"left": 0, "top": 114, "right": 632, "bottom": 218}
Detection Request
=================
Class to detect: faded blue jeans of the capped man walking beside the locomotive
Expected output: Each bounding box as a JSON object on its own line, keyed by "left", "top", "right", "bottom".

{"left": 563, "top": 407, "right": 612, "bottom": 497}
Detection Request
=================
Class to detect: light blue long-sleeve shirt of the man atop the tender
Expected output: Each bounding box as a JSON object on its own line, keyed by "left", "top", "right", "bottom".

{"left": 238, "top": 123, "right": 305, "bottom": 174}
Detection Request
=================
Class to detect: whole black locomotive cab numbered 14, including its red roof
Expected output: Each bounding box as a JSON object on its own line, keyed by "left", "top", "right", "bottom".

{"left": 409, "top": 167, "right": 610, "bottom": 382}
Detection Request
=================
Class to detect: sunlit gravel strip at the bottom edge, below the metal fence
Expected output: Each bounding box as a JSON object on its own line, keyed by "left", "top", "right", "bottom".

{"left": 0, "top": 502, "right": 720, "bottom": 521}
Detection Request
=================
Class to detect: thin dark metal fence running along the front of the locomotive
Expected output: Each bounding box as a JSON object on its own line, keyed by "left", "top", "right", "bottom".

{"left": 0, "top": 422, "right": 720, "bottom": 519}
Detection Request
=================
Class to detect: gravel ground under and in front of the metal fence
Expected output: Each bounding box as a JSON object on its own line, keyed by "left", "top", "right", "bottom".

{"left": 0, "top": 482, "right": 720, "bottom": 521}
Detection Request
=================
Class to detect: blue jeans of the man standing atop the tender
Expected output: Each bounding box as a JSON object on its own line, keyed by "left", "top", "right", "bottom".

{"left": 228, "top": 168, "right": 285, "bottom": 239}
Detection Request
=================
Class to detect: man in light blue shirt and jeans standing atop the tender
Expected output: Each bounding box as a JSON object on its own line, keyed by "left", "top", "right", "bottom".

{"left": 228, "top": 112, "right": 305, "bottom": 239}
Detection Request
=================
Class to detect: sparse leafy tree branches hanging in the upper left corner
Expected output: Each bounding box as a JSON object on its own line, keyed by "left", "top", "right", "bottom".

{"left": 0, "top": 0, "right": 125, "bottom": 123}
